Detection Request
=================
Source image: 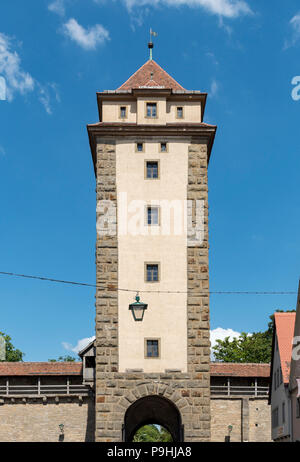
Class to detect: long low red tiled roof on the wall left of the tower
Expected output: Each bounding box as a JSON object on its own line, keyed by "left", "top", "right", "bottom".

{"left": 0, "top": 362, "right": 82, "bottom": 376}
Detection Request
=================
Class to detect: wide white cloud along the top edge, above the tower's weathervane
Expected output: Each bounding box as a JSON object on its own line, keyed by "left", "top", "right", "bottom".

{"left": 123, "top": 0, "right": 252, "bottom": 18}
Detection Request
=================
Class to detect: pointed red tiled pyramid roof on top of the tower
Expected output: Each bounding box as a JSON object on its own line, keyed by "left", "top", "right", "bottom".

{"left": 118, "top": 60, "right": 184, "bottom": 90}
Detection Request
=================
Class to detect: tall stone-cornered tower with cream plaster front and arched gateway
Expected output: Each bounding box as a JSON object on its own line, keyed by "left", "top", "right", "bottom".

{"left": 88, "top": 56, "right": 216, "bottom": 442}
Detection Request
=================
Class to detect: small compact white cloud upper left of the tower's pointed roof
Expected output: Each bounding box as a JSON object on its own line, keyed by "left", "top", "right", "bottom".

{"left": 63, "top": 18, "right": 110, "bottom": 50}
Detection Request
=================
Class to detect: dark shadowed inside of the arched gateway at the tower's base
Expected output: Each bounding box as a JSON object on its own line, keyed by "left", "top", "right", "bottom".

{"left": 123, "top": 395, "right": 183, "bottom": 442}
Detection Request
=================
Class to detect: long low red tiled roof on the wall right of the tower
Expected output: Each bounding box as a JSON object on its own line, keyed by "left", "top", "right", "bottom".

{"left": 210, "top": 363, "right": 270, "bottom": 377}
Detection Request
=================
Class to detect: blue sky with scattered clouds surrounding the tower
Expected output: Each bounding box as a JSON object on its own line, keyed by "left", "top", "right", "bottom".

{"left": 0, "top": 0, "right": 300, "bottom": 361}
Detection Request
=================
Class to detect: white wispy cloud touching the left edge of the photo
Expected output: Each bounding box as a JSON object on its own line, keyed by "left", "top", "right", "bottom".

{"left": 0, "top": 32, "right": 35, "bottom": 101}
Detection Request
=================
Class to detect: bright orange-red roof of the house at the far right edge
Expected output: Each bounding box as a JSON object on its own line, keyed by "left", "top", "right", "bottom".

{"left": 274, "top": 313, "right": 296, "bottom": 383}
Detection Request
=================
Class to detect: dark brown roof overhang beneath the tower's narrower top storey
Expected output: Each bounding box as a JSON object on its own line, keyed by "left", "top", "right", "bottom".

{"left": 87, "top": 123, "right": 217, "bottom": 175}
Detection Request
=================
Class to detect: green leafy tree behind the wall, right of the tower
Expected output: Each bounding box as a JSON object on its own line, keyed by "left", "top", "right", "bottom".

{"left": 213, "top": 310, "right": 295, "bottom": 363}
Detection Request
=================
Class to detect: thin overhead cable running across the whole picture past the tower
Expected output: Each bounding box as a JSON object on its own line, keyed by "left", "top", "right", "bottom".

{"left": 0, "top": 271, "right": 297, "bottom": 295}
